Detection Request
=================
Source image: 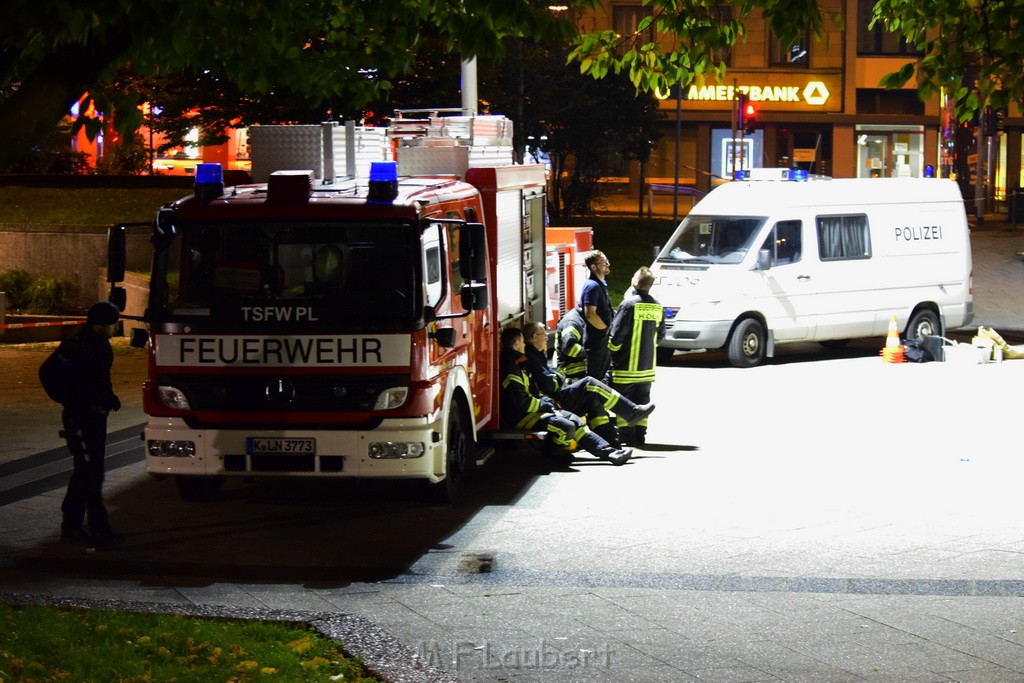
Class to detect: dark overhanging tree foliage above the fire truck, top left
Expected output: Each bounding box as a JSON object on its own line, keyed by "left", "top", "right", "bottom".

{"left": 0, "top": 0, "right": 591, "bottom": 169}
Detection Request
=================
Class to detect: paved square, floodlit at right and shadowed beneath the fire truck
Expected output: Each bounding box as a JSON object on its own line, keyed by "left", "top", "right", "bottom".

{"left": 0, "top": 340, "right": 1024, "bottom": 681}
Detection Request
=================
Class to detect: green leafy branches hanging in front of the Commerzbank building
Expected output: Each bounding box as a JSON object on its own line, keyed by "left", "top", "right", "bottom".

{"left": 569, "top": 0, "right": 1024, "bottom": 120}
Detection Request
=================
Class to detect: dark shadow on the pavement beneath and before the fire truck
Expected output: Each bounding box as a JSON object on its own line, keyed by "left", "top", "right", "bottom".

{"left": 0, "top": 449, "right": 569, "bottom": 587}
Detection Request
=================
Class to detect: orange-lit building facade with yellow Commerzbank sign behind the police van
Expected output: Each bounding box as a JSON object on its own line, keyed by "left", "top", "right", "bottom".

{"left": 577, "top": 0, "right": 1024, "bottom": 212}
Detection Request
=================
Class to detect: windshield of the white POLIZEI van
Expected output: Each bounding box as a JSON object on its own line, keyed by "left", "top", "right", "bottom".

{"left": 657, "top": 216, "right": 765, "bottom": 263}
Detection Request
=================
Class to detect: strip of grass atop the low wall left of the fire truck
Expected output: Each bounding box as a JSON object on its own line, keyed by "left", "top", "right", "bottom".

{"left": 0, "top": 185, "right": 190, "bottom": 225}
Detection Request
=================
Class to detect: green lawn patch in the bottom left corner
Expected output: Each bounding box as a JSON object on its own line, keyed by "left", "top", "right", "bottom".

{"left": 0, "top": 605, "right": 379, "bottom": 683}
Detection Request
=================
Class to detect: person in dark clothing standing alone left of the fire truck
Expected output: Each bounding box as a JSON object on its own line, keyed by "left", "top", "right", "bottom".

{"left": 57, "top": 301, "right": 124, "bottom": 547}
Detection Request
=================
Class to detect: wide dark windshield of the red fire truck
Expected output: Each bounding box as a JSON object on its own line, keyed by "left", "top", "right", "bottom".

{"left": 154, "top": 221, "right": 423, "bottom": 329}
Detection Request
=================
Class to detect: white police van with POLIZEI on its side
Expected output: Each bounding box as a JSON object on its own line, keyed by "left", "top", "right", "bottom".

{"left": 651, "top": 169, "right": 974, "bottom": 368}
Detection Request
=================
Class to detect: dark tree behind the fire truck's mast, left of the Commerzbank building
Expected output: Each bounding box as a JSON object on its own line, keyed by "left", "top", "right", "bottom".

{"left": 370, "top": 32, "right": 657, "bottom": 222}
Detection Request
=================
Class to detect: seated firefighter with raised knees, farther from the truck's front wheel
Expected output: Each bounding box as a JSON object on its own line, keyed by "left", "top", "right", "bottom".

{"left": 522, "top": 323, "right": 654, "bottom": 445}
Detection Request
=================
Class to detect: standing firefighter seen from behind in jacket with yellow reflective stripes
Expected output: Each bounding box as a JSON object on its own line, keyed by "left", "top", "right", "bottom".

{"left": 608, "top": 266, "right": 665, "bottom": 445}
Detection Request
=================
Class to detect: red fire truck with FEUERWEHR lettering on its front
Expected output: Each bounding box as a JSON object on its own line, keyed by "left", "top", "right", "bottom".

{"left": 109, "top": 113, "right": 589, "bottom": 502}
